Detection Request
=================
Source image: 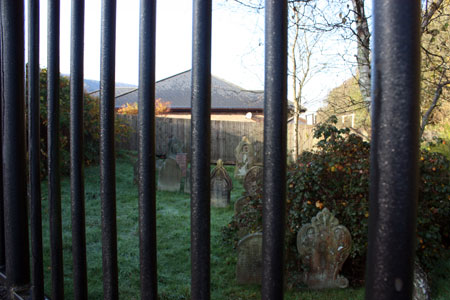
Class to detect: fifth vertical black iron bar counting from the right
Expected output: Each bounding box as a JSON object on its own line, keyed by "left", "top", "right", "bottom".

{"left": 100, "top": 0, "right": 119, "bottom": 300}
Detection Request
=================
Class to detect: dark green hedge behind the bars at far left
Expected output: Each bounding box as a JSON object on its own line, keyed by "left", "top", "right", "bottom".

{"left": 29, "top": 69, "right": 130, "bottom": 177}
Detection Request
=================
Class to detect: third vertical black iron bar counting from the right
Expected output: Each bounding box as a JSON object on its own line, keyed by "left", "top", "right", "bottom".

{"left": 191, "top": 0, "right": 212, "bottom": 300}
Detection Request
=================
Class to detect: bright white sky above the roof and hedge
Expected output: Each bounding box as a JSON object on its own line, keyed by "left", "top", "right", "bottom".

{"left": 26, "top": 0, "right": 356, "bottom": 110}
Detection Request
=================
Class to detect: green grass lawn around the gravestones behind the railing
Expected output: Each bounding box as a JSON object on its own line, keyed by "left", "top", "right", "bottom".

{"left": 42, "top": 157, "right": 450, "bottom": 300}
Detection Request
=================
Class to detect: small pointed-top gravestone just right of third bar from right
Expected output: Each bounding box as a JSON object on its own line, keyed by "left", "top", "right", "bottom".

{"left": 211, "top": 159, "right": 233, "bottom": 207}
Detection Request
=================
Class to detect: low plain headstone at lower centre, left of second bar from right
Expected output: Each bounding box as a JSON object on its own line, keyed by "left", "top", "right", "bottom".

{"left": 236, "top": 232, "right": 262, "bottom": 284}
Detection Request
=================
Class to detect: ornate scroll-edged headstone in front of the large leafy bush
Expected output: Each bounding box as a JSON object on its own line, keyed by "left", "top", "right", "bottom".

{"left": 297, "top": 208, "right": 352, "bottom": 289}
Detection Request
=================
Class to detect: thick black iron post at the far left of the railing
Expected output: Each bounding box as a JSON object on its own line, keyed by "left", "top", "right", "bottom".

{"left": 0, "top": 0, "right": 30, "bottom": 289}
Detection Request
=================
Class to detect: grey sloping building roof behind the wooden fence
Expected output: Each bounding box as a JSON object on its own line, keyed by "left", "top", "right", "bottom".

{"left": 115, "top": 70, "right": 264, "bottom": 111}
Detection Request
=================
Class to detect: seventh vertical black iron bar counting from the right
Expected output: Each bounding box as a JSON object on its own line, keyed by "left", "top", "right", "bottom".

{"left": 47, "top": 0, "right": 64, "bottom": 300}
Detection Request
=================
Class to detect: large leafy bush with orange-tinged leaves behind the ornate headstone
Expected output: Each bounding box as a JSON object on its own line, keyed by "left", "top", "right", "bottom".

{"left": 224, "top": 117, "right": 450, "bottom": 286}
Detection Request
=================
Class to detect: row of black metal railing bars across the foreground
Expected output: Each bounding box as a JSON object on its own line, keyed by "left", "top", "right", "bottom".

{"left": 0, "top": 0, "right": 420, "bottom": 300}
